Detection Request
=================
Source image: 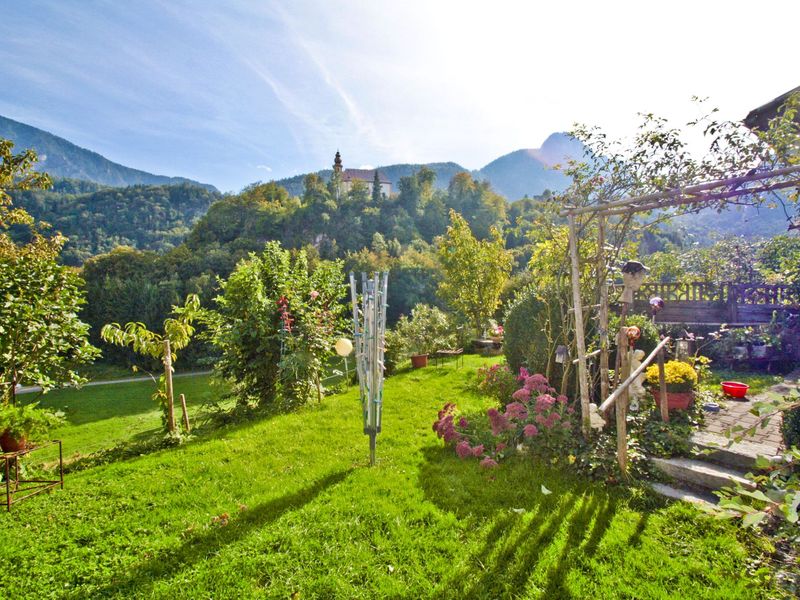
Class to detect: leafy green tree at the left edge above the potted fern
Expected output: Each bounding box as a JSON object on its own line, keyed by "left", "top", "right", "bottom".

{"left": 0, "top": 139, "right": 99, "bottom": 404}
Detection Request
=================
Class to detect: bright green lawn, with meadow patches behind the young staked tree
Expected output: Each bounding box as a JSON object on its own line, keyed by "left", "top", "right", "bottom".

{"left": 0, "top": 357, "right": 771, "bottom": 599}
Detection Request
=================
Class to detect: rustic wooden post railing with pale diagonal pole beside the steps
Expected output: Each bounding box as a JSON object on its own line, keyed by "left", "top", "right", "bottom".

{"left": 598, "top": 327, "right": 670, "bottom": 477}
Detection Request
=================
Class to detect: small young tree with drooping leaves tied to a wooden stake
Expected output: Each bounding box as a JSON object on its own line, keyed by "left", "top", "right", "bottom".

{"left": 100, "top": 294, "right": 200, "bottom": 433}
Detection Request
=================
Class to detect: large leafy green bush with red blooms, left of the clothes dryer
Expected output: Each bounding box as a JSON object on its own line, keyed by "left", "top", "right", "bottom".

{"left": 206, "top": 242, "right": 345, "bottom": 408}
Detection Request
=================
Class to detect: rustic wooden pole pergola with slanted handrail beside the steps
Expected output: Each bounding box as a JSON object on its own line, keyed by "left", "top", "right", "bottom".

{"left": 560, "top": 166, "right": 800, "bottom": 473}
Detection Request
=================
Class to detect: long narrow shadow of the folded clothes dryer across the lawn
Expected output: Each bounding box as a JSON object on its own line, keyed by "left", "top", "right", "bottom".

{"left": 97, "top": 469, "right": 352, "bottom": 598}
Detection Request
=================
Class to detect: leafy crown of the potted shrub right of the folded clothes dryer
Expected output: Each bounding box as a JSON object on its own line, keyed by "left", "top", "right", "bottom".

{"left": 389, "top": 304, "right": 456, "bottom": 355}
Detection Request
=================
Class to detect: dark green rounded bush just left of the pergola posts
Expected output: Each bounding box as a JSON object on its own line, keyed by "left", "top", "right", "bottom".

{"left": 503, "top": 287, "right": 563, "bottom": 374}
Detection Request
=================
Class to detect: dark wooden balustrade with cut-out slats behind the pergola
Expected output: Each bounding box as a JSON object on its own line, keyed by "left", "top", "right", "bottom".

{"left": 633, "top": 282, "right": 800, "bottom": 325}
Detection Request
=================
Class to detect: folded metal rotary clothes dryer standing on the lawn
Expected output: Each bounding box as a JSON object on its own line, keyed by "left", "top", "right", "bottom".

{"left": 350, "top": 272, "right": 389, "bottom": 465}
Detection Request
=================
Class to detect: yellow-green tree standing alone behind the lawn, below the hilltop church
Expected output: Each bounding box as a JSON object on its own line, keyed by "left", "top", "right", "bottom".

{"left": 438, "top": 210, "right": 513, "bottom": 335}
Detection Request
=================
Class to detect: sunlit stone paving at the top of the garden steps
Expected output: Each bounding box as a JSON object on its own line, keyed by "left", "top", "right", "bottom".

{"left": 703, "top": 370, "right": 800, "bottom": 455}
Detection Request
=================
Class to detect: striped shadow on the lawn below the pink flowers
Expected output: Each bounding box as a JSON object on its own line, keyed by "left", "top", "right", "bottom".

{"left": 420, "top": 448, "right": 628, "bottom": 598}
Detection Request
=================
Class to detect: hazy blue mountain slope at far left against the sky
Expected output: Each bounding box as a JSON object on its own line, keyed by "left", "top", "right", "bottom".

{"left": 0, "top": 116, "right": 217, "bottom": 192}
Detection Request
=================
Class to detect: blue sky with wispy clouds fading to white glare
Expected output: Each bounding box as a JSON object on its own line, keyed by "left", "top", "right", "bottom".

{"left": 0, "top": 0, "right": 800, "bottom": 191}
